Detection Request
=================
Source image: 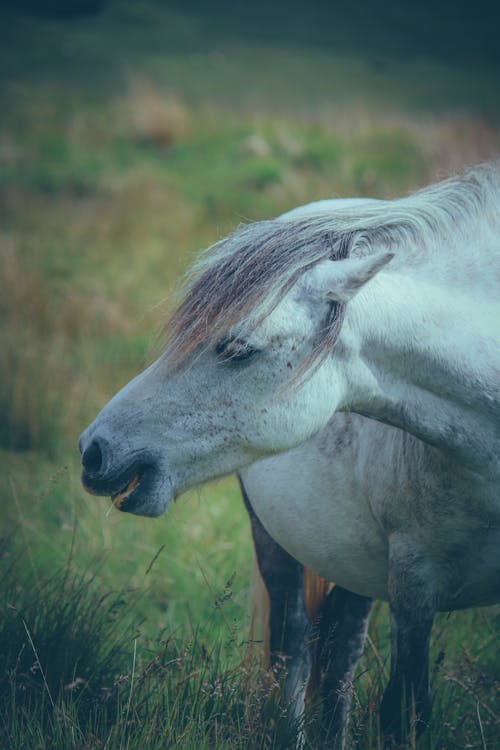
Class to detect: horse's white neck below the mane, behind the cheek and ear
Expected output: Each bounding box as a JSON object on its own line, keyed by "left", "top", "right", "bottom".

{"left": 346, "top": 250, "right": 500, "bottom": 471}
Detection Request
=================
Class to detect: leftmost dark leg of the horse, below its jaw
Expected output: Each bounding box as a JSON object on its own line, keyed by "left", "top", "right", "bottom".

{"left": 240, "top": 479, "right": 312, "bottom": 719}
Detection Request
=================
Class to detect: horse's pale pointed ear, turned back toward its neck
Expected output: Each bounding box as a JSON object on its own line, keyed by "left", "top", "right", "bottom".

{"left": 323, "top": 253, "right": 394, "bottom": 302}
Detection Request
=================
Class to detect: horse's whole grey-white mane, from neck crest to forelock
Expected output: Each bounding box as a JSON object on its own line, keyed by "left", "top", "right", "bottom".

{"left": 164, "top": 164, "right": 500, "bottom": 366}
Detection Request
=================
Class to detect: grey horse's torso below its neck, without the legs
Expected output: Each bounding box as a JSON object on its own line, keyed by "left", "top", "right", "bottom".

{"left": 240, "top": 414, "right": 500, "bottom": 611}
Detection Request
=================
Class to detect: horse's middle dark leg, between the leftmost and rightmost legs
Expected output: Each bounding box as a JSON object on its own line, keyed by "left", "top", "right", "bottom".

{"left": 315, "top": 586, "right": 373, "bottom": 738}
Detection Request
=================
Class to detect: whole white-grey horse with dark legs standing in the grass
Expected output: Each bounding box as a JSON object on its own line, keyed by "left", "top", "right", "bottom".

{"left": 79, "top": 163, "right": 500, "bottom": 745}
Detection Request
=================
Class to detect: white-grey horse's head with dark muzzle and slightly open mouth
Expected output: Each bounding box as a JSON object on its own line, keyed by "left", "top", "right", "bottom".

{"left": 79, "top": 219, "right": 392, "bottom": 516}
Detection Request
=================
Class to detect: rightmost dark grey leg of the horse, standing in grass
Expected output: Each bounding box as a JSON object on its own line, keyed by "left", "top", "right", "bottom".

{"left": 380, "top": 543, "right": 437, "bottom": 745}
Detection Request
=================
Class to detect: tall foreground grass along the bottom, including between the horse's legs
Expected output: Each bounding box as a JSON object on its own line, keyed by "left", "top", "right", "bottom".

{"left": 0, "top": 541, "right": 500, "bottom": 750}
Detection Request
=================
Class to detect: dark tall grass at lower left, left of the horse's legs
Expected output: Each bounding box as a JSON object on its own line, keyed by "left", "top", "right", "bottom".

{"left": 0, "top": 544, "right": 295, "bottom": 749}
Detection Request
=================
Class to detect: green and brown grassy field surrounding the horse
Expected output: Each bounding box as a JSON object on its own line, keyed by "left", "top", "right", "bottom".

{"left": 0, "top": 1, "right": 500, "bottom": 750}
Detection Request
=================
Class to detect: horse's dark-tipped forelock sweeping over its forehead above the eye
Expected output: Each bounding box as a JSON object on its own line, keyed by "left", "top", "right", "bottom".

{"left": 165, "top": 219, "right": 349, "bottom": 366}
